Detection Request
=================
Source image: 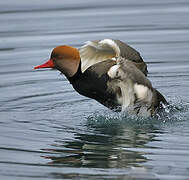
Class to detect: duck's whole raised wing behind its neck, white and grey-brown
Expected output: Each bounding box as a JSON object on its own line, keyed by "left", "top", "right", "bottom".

{"left": 79, "top": 39, "right": 148, "bottom": 75}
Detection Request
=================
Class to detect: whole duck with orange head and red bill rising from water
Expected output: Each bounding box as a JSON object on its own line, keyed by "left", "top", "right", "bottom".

{"left": 34, "top": 39, "right": 167, "bottom": 116}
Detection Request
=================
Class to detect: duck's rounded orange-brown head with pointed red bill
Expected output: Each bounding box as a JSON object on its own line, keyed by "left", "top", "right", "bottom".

{"left": 34, "top": 45, "right": 80, "bottom": 77}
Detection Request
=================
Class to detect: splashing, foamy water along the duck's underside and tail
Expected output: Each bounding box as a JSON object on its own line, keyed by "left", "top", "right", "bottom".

{"left": 87, "top": 98, "right": 189, "bottom": 128}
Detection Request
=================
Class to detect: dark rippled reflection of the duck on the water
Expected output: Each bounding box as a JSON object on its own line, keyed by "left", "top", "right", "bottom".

{"left": 41, "top": 113, "right": 158, "bottom": 168}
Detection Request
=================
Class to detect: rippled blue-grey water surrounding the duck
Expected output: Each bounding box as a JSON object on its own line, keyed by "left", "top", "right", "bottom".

{"left": 0, "top": 0, "right": 189, "bottom": 180}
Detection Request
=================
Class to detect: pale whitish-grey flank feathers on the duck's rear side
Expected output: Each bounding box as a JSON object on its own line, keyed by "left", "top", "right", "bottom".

{"left": 108, "top": 61, "right": 153, "bottom": 117}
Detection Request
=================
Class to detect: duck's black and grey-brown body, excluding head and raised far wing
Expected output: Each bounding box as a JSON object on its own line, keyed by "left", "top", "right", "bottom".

{"left": 68, "top": 59, "right": 166, "bottom": 116}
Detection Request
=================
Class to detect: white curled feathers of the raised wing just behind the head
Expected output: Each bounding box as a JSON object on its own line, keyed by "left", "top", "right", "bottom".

{"left": 79, "top": 39, "right": 120, "bottom": 72}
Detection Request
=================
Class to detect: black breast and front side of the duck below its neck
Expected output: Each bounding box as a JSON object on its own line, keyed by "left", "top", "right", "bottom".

{"left": 69, "top": 60, "right": 119, "bottom": 109}
